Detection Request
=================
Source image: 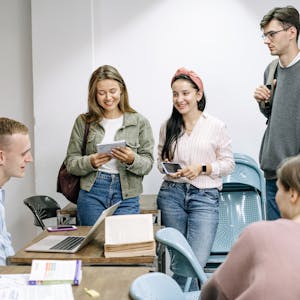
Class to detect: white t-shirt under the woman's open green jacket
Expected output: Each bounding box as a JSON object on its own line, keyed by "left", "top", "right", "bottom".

{"left": 98, "top": 116, "right": 123, "bottom": 174}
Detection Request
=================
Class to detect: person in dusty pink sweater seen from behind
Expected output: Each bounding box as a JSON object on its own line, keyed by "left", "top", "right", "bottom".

{"left": 201, "top": 155, "right": 300, "bottom": 300}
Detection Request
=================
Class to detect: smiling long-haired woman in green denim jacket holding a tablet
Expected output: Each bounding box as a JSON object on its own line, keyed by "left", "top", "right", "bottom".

{"left": 65, "top": 65, "right": 154, "bottom": 226}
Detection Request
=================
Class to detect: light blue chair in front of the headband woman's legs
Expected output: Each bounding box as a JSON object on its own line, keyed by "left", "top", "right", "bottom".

{"left": 155, "top": 227, "right": 207, "bottom": 299}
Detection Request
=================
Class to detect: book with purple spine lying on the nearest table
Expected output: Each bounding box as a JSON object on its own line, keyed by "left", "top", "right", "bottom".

{"left": 28, "top": 259, "right": 82, "bottom": 285}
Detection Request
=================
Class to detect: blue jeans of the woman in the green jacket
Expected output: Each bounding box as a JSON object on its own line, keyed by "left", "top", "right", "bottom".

{"left": 77, "top": 172, "right": 140, "bottom": 226}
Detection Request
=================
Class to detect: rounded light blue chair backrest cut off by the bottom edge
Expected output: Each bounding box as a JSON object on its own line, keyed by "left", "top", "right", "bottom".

{"left": 129, "top": 272, "right": 185, "bottom": 300}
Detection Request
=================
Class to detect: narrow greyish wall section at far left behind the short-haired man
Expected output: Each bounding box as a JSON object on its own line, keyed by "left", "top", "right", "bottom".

{"left": 0, "top": 0, "right": 35, "bottom": 250}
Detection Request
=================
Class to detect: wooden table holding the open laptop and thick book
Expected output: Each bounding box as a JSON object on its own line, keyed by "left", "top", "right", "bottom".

{"left": 8, "top": 224, "right": 165, "bottom": 272}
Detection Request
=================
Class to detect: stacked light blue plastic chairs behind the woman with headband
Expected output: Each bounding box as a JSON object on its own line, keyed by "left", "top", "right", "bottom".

{"left": 205, "top": 153, "right": 266, "bottom": 273}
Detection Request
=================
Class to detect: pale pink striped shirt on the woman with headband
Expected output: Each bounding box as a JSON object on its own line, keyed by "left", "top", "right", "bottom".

{"left": 157, "top": 113, "right": 234, "bottom": 189}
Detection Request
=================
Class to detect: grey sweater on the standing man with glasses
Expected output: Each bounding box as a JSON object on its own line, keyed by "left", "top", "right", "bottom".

{"left": 259, "top": 61, "right": 300, "bottom": 179}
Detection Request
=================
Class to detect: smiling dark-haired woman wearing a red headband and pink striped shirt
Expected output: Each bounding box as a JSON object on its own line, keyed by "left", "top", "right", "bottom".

{"left": 157, "top": 68, "right": 234, "bottom": 290}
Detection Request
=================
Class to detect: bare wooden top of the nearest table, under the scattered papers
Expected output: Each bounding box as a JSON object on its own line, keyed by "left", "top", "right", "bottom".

{"left": 0, "top": 266, "right": 150, "bottom": 300}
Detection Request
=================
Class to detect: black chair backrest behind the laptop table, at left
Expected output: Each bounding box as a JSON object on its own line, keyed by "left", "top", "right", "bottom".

{"left": 24, "top": 195, "right": 60, "bottom": 230}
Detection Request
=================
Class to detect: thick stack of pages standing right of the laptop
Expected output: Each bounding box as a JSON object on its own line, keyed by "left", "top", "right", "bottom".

{"left": 104, "top": 214, "right": 155, "bottom": 257}
